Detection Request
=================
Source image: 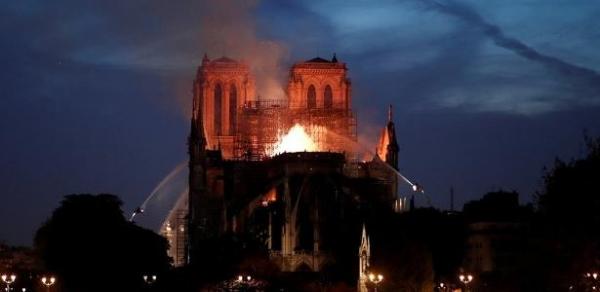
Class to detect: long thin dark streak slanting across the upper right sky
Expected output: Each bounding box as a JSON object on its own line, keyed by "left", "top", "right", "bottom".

{"left": 421, "top": 0, "right": 600, "bottom": 95}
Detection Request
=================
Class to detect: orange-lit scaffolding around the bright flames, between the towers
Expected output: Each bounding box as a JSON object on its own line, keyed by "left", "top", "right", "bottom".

{"left": 234, "top": 100, "right": 357, "bottom": 160}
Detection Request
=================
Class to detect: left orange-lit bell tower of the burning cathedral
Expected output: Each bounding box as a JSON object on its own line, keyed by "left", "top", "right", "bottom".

{"left": 194, "top": 54, "right": 256, "bottom": 158}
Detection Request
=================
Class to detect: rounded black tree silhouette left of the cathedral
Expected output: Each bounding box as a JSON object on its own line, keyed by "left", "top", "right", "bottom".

{"left": 34, "top": 194, "right": 170, "bottom": 292}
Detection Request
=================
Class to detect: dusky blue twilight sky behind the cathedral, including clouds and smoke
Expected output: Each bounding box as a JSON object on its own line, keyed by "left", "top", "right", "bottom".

{"left": 0, "top": 0, "right": 600, "bottom": 245}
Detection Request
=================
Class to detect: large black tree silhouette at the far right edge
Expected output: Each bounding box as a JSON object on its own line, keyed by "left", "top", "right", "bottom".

{"left": 538, "top": 137, "right": 600, "bottom": 291}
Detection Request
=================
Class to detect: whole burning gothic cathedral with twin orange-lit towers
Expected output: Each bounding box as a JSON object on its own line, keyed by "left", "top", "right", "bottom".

{"left": 163, "top": 55, "right": 405, "bottom": 278}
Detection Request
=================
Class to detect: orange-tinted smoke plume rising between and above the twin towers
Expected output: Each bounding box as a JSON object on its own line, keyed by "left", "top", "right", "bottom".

{"left": 200, "top": 0, "right": 287, "bottom": 99}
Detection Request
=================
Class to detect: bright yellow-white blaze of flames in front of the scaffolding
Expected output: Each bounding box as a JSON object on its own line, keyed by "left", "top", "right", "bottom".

{"left": 269, "top": 124, "right": 324, "bottom": 156}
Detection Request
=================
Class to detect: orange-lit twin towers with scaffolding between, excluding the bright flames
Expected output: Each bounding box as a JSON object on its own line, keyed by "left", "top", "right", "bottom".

{"left": 193, "top": 55, "right": 356, "bottom": 160}
